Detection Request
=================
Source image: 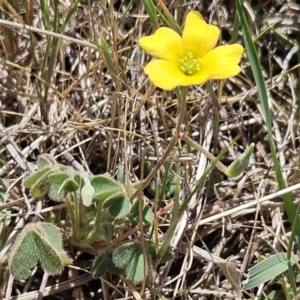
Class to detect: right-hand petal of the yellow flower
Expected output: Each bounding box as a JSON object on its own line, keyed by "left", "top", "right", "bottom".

{"left": 198, "top": 44, "right": 244, "bottom": 79}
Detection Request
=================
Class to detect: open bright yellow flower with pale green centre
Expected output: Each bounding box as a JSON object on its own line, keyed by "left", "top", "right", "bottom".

{"left": 139, "top": 11, "right": 243, "bottom": 91}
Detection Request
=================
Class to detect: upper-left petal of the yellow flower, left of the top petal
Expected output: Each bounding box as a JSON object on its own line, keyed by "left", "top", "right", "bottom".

{"left": 139, "top": 27, "right": 183, "bottom": 64}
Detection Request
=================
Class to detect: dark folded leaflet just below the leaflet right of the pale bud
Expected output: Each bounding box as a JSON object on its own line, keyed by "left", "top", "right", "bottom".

{"left": 103, "top": 191, "right": 130, "bottom": 219}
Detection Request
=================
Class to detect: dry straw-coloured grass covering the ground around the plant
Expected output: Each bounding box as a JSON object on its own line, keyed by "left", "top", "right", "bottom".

{"left": 0, "top": 1, "right": 300, "bottom": 299}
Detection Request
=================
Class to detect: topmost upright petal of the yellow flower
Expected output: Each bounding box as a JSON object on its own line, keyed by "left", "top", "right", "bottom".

{"left": 182, "top": 11, "right": 220, "bottom": 58}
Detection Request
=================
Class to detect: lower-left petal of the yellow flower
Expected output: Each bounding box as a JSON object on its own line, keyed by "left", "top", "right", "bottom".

{"left": 144, "top": 59, "right": 185, "bottom": 91}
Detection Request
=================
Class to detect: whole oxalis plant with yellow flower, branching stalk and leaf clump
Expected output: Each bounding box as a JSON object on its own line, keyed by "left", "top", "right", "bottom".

{"left": 9, "top": 11, "right": 254, "bottom": 282}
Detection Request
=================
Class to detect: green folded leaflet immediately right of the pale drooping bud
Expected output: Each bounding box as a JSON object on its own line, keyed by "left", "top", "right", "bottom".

{"left": 91, "top": 175, "right": 124, "bottom": 200}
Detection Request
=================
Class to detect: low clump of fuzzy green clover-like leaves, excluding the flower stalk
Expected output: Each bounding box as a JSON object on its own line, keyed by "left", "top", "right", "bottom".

{"left": 9, "top": 154, "right": 172, "bottom": 282}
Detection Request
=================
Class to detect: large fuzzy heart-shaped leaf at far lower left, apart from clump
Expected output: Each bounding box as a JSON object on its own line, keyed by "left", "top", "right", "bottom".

{"left": 8, "top": 223, "right": 71, "bottom": 279}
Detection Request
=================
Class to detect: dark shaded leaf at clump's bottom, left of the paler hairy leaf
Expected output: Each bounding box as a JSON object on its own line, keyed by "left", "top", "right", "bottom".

{"left": 91, "top": 252, "right": 123, "bottom": 278}
